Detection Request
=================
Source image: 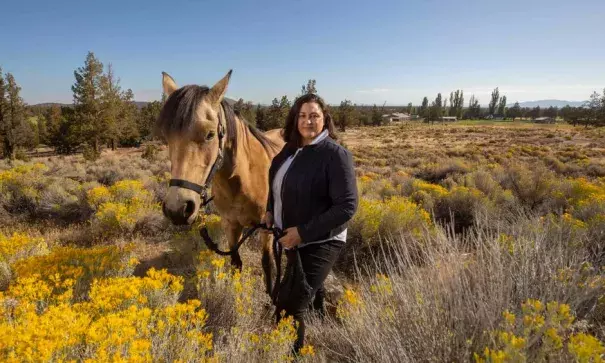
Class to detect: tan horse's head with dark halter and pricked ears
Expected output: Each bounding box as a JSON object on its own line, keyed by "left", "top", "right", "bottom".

{"left": 157, "top": 71, "right": 231, "bottom": 224}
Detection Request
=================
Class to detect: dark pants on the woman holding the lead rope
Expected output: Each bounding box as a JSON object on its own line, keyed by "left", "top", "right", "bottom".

{"left": 286, "top": 240, "right": 344, "bottom": 352}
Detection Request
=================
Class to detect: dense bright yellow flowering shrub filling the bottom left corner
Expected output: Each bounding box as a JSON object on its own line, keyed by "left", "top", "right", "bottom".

{"left": 0, "top": 270, "right": 213, "bottom": 362}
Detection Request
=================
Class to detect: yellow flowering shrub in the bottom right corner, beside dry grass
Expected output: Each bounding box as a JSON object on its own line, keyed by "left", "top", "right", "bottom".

{"left": 474, "top": 299, "right": 604, "bottom": 362}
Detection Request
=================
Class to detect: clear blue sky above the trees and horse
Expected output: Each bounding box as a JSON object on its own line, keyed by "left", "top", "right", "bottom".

{"left": 0, "top": 0, "right": 605, "bottom": 105}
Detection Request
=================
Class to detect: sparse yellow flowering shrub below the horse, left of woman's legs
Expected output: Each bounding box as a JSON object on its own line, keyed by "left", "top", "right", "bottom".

{"left": 197, "top": 251, "right": 315, "bottom": 362}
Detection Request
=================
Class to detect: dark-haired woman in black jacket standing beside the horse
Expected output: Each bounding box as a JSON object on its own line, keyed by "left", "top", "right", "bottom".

{"left": 263, "top": 94, "right": 358, "bottom": 351}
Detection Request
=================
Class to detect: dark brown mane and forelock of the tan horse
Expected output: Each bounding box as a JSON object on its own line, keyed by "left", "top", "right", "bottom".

{"left": 156, "top": 85, "right": 277, "bottom": 153}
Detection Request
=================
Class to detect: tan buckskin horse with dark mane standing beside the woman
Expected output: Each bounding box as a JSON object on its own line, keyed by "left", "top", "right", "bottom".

{"left": 156, "top": 70, "right": 284, "bottom": 294}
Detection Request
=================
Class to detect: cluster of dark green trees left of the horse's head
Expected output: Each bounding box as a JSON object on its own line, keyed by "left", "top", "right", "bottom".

{"left": 0, "top": 52, "right": 162, "bottom": 159}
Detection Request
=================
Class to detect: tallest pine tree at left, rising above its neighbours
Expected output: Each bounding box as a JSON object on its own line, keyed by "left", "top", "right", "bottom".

{"left": 71, "top": 52, "right": 105, "bottom": 153}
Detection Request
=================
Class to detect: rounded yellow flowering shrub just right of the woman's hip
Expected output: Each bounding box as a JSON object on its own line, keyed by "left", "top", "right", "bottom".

{"left": 351, "top": 197, "right": 432, "bottom": 242}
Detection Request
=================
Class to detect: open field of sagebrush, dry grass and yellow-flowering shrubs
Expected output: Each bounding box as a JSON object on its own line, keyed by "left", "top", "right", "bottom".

{"left": 0, "top": 122, "right": 605, "bottom": 362}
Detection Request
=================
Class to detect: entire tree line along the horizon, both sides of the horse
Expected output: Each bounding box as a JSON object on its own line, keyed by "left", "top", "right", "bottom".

{"left": 0, "top": 52, "right": 605, "bottom": 159}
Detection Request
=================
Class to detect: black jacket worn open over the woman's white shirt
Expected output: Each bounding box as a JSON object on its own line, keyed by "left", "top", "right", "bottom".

{"left": 267, "top": 137, "right": 358, "bottom": 246}
